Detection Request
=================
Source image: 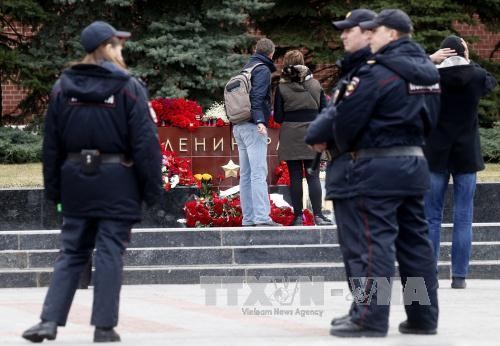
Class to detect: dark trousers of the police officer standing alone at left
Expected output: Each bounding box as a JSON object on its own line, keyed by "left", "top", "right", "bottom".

{"left": 41, "top": 217, "right": 133, "bottom": 327}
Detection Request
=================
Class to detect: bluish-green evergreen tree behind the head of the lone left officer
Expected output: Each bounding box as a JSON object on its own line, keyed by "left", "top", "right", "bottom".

{"left": 7, "top": 0, "right": 272, "bottom": 114}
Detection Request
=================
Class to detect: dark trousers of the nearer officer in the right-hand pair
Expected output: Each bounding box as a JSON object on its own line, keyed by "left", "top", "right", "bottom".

{"left": 334, "top": 196, "right": 439, "bottom": 332}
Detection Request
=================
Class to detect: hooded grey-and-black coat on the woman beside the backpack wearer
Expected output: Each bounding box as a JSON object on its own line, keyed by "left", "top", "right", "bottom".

{"left": 274, "top": 65, "right": 326, "bottom": 161}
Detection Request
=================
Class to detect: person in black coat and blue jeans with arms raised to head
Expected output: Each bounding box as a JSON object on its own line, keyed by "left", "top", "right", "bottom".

{"left": 424, "top": 35, "right": 496, "bottom": 288}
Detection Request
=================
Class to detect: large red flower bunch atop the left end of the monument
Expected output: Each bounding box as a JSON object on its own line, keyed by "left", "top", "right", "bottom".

{"left": 151, "top": 97, "right": 203, "bottom": 132}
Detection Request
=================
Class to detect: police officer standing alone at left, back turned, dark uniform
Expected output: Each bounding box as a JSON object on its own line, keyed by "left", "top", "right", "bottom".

{"left": 23, "top": 22, "right": 161, "bottom": 342}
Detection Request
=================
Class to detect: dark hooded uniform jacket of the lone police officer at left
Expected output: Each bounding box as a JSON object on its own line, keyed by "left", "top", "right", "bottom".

{"left": 43, "top": 63, "right": 161, "bottom": 221}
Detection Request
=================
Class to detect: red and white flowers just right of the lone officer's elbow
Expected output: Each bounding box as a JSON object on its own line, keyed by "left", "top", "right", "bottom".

{"left": 161, "top": 143, "right": 197, "bottom": 191}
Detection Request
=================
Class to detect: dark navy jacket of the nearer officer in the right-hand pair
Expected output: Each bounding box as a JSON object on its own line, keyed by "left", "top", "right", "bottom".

{"left": 326, "top": 38, "right": 440, "bottom": 199}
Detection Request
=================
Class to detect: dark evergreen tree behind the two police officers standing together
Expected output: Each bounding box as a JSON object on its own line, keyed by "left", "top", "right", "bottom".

{"left": 254, "top": 0, "right": 500, "bottom": 126}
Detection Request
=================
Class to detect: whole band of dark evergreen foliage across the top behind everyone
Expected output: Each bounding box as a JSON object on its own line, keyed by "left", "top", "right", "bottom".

{"left": 0, "top": 0, "right": 500, "bottom": 117}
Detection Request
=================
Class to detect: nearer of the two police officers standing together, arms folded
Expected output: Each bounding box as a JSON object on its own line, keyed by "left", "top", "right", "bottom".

{"left": 306, "top": 9, "right": 440, "bottom": 337}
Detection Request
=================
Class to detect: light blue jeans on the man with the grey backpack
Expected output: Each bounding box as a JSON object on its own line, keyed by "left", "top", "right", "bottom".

{"left": 233, "top": 123, "right": 271, "bottom": 226}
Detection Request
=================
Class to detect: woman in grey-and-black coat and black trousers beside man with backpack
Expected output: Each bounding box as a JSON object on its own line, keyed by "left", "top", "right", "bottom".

{"left": 274, "top": 50, "right": 331, "bottom": 226}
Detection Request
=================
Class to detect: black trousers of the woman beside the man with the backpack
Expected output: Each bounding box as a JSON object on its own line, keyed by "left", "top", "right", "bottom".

{"left": 286, "top": 160, "right": 322, "bottom": 216}
